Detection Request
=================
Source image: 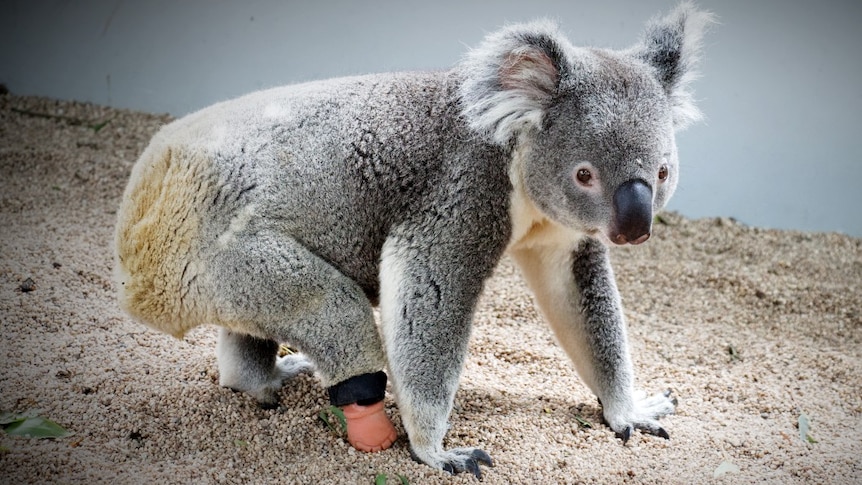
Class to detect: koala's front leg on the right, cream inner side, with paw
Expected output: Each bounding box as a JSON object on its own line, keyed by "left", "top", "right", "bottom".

{"left": 512, "top": 238, "right": 675, "bottom": 441}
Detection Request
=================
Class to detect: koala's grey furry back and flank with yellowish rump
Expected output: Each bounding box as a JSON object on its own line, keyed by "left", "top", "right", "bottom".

{"left": 116, "top": 73, "right": 470, "bottom": 336}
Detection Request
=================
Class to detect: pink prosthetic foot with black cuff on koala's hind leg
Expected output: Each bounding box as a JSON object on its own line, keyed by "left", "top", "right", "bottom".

{"left": 328, "top": 371, "right": 398, "bottom": 452}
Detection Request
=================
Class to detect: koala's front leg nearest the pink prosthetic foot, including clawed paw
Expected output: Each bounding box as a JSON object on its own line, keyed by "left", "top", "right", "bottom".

{"left": 380, "top": 236, "right": 492, "bottom": 477}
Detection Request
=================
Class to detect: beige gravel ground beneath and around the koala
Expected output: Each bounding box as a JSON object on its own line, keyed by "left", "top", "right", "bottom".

{"left": 0, "top": 95, "right": 862, "bottom": 484}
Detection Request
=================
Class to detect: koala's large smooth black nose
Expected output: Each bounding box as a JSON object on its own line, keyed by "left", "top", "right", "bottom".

{"left": 610, "top": 179, "right": 652, "bottom": 244}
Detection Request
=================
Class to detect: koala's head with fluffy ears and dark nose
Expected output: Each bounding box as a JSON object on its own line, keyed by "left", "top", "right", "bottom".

{"left": 460, "top": 3, "right": 712, "bottom": 244}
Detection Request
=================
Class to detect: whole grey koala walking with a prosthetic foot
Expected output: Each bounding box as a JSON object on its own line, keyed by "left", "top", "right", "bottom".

{"left": 115, "top": 3, "right": 713, "bottom": 476}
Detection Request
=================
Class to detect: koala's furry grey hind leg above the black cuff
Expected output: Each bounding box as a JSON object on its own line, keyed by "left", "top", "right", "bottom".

{"left": 209, "top": 231, "right": 385, "bottom": 386}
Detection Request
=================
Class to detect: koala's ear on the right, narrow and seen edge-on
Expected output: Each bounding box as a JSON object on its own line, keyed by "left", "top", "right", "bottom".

{"left": 632, "top": 2, "right": 715, "bottom": 129}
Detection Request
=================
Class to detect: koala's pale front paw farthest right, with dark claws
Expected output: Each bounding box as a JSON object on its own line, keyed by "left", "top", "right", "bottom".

{"left": 604, "top": 389, "right": 677, "bottom": 443}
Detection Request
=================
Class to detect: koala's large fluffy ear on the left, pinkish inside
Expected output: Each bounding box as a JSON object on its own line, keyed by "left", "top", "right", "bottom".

{"left": 458, "top": 21, "right": 570, "bottom": 146}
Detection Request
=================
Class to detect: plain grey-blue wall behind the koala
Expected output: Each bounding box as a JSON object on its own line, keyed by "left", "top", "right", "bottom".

{"left": 0, "top": 0, "right": 862, "bottom": 236}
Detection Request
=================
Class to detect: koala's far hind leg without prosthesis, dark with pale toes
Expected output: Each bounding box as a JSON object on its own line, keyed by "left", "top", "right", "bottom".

{"left": 216, "top": 328, "right": 314, "bottom": 408}
